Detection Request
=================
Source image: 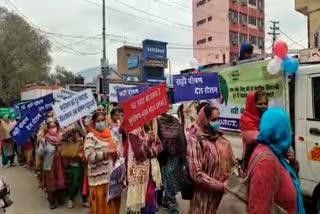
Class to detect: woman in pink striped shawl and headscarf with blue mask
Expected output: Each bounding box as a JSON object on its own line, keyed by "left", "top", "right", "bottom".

{"left": 187, "top": 105, "right": 234, "bottom": 214}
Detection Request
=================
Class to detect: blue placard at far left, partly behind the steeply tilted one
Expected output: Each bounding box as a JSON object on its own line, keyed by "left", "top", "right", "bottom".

{"left": 19, "top": 94, "right": 54, "bottom": 117}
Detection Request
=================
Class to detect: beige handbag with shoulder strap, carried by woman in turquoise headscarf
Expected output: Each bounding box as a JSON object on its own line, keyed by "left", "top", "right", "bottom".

{"left": 217, "top": 152, "right": 288, "bottom": 214}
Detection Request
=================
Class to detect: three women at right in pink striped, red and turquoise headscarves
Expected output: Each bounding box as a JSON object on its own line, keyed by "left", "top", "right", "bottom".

{"left": 179, "top": 90, "right": 305, "bottom": 214}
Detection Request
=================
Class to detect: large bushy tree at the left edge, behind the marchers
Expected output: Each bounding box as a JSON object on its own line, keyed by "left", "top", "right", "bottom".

{"left": 0, "top": 7, "right": 51, "bottom": 104}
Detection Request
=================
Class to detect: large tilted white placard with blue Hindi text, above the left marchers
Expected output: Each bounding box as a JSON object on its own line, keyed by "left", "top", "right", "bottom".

{"left": 53, "top": 89, "right": 97, "bottom": 128}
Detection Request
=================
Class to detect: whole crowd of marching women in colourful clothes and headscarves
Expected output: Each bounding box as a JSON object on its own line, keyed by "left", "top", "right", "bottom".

{"left": 1, "top": 90, "right": 305, "bottom": 214}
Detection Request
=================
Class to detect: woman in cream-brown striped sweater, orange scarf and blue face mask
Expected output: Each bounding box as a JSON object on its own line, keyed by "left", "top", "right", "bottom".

{"left": 84, "top": 112, "right": 121, "bottom": 214}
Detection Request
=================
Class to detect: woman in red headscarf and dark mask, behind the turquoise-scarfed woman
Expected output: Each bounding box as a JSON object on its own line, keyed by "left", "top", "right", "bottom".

{"left": 240, "top": 90, "right": 268, "bottom": 154}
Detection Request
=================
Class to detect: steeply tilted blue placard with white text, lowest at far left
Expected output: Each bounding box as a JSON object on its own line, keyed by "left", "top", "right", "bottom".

{"left": 10, "top": 107, "right": 45, "bottom": 146}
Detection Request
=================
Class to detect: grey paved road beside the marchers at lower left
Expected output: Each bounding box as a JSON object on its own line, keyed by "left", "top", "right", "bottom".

{"left": 0, "top": 166, "right": 188, "bottom": 214}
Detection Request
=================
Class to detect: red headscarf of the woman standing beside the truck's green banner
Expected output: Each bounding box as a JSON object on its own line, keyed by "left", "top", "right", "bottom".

{"left": 240, "top": 91, "right": 261, "bottom": 131}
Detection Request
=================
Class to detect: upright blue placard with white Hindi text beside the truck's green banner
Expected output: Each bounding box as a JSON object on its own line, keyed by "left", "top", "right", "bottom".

{"left": 173, "top": 73, "right": 220, "bottom": 102}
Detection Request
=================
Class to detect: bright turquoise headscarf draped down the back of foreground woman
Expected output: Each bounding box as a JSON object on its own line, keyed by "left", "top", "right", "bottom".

{"left": 258, "top": 108, "right": 305, "bottom": 214}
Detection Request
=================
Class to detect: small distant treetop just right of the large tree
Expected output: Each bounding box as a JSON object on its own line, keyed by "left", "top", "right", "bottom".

{"left": 48, "top": 65, "right": 75, "bottom": 85}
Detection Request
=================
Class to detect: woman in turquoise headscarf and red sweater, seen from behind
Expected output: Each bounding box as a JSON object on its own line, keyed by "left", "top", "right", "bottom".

{"left": 244, "top": 108, "right": 305, "bottom": 214}
